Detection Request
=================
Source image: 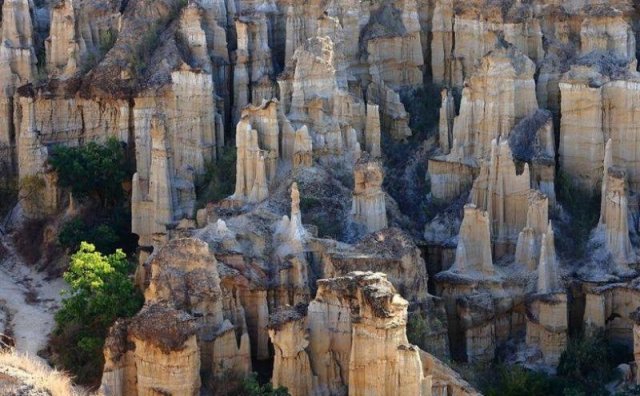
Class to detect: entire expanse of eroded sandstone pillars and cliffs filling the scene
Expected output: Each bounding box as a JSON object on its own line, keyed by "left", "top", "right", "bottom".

{"left": 8, "top": 0, "right": 640, "bottom": 395}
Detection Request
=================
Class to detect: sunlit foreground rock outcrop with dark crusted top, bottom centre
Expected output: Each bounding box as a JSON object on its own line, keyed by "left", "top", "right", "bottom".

{"left": 270, "top": 272, "right": 476, "bottom": 395}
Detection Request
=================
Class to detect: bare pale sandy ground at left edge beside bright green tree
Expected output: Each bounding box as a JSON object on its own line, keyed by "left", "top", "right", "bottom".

{"left": 0, "top": 237, "right": 65, "bottom": 356}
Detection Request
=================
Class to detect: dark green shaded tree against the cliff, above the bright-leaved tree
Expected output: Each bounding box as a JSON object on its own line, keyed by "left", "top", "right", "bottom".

{"left": 49, "top": 138, "right": 129, "bottom": 208}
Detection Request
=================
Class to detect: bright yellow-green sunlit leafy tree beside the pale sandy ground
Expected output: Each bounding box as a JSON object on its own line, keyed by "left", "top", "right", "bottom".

{"left": 52, "top": 242, "right": 143, "bottom": 384}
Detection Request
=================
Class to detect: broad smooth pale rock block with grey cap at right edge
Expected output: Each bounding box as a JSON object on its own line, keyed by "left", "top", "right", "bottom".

{"left": 560, "top": 62, "right": 638, "bottom": 191}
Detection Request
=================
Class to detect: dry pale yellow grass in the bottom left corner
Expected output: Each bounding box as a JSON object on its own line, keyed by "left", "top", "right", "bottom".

{"left": 0, "top": 350, "right": 86, "bottom": 396}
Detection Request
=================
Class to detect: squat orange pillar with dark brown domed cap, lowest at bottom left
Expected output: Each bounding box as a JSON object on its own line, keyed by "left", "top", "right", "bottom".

{"left": 100, "top": 304, "right": 201, "bottom": 396}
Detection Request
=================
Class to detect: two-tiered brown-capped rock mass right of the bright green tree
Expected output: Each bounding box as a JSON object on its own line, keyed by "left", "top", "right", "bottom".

{"left": 102, "top": 239, "right": 254, "bottom": 395}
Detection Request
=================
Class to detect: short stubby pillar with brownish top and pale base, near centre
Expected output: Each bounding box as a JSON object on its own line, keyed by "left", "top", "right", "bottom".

{"left": 351, "top": 156, "right": 387, "bottom": 232}
